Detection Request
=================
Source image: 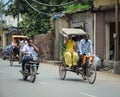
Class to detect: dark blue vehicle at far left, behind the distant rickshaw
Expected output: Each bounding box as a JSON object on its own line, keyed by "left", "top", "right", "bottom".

{"left": 2, "top": 44, "right": 12, "bottom": 60}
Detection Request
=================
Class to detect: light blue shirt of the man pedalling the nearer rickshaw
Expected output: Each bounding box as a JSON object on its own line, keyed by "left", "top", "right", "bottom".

{"left": 77, "top": 39, "right": 93, "bottom": 54}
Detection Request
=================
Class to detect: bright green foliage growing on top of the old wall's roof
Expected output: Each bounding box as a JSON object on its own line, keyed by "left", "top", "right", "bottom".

{"left": 65, "top": 4, "right": 90, "bottom": 13}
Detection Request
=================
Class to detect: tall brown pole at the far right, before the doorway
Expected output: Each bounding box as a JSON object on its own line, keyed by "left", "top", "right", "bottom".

{"left": 115, "top": 0, "right": 120, "bottom": 61}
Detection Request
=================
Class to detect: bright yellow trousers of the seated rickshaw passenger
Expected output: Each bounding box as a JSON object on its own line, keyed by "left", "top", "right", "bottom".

{"left": 64, "top": 52, "right": 78, "bottom": 67}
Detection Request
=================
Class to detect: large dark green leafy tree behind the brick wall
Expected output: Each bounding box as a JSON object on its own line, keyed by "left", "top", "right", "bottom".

{"left": 3, "top": 0, "right": 92, "bottom": 36}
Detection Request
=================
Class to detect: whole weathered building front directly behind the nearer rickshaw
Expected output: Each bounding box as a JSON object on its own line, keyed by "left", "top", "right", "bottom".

{"left": 52, "top": 9, "right": 94, "bottom": 60}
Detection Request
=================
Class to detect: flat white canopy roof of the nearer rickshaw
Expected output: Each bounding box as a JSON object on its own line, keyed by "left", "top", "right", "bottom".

{"left": 60, "top": 28, "right": 87, "bottom": 37}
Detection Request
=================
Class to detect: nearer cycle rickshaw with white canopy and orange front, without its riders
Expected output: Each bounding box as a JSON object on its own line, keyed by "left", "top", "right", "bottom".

{"left": 59, "top": 28, "right": 97, "bottom": 84}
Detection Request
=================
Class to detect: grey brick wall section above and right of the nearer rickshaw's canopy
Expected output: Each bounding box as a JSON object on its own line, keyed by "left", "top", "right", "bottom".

{"left": 71, "top": 12, "right": 94, "bottom": 41}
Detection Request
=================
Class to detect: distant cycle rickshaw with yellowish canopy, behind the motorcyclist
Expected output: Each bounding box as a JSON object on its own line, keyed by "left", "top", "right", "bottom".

{"left": 10, "top": 35, "right": 28, "bottom": 66}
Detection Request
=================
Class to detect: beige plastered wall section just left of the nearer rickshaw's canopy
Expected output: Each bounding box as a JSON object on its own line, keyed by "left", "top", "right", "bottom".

{"left": 54, "top": 17, "right": 69, "bottom": 60}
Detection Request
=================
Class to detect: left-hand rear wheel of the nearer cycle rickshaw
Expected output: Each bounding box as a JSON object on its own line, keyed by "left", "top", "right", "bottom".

{"left": 59, "top": 62, "right": 67, "bottom": 80}
